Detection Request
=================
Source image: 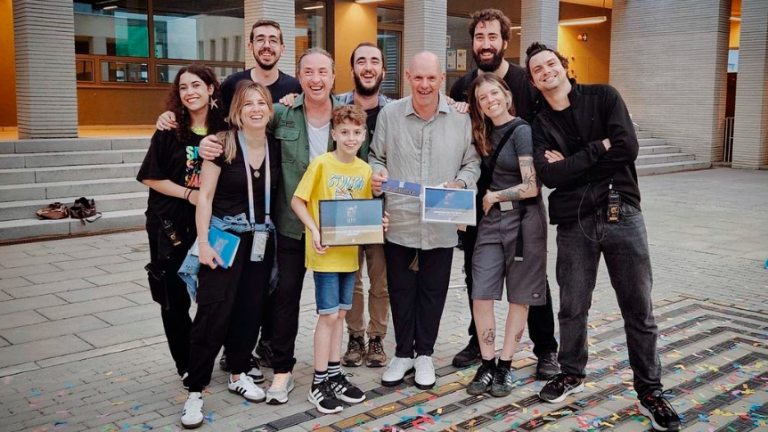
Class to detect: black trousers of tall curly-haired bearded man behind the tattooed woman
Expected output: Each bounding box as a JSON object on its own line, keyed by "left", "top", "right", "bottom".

{"left": 459, "top": 223, "right": 557, "bottom": 357}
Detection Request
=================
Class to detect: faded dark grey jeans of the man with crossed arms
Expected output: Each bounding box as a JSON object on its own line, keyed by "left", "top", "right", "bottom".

{"left": 557, "top": 204, "right": 662, "bottom": 397}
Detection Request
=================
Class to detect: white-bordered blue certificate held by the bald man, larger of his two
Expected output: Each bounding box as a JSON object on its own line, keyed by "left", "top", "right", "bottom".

{"left": 421, "top": 187, "right": 477, "bottom": 226}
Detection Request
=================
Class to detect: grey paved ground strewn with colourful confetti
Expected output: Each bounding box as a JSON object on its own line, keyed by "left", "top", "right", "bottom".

{"left": 0, "top": 169, "right": 768, "bottom": 432}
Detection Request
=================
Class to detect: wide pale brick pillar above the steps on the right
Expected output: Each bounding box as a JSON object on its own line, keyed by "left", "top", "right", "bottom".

{"left": 610, "top": 0, "right": 728, "bottom": 161}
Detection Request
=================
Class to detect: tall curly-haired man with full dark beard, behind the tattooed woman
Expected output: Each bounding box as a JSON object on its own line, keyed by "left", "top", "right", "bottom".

{"left": 451, "top": 9, "right": 560, "bottom": 380}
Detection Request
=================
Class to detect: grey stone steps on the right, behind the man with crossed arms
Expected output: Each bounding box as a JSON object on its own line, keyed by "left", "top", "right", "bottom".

{"left": 635, "top": 130, "right": 712, "bottom": 176}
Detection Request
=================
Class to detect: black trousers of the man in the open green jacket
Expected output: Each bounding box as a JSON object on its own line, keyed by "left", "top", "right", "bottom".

{"left": 270, "top": 233, "right": 307, "bottom": 373}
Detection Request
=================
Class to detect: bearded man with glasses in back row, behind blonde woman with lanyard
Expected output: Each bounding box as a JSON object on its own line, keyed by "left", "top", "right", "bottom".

{"left": 157, "top": 20, "right": 302, "bottom": 384}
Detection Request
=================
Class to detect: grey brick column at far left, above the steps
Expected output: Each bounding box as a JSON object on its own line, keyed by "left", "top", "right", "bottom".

{"left": 13, "top": 0, "right": 77, "bottom": 139}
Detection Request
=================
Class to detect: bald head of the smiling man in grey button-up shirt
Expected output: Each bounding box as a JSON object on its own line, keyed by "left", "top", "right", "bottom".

{"left": 405, "top": 51, "right": 445, "bottom": 119}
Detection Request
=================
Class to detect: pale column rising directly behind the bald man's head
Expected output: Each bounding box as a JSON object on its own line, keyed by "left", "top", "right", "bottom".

{"left": 403, "top": 0, "right": 448, "bottom": 96}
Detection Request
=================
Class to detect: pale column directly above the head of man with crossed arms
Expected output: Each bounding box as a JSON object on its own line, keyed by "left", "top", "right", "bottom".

{"left": 520, "top": 0, "right": 560, "bottom": 65}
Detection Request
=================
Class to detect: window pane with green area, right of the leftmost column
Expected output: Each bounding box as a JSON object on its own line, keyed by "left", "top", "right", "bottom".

{"left": 74, "top": 0, "right": 149, "bottom": 57}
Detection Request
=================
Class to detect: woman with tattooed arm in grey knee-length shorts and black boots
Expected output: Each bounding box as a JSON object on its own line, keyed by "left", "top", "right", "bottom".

{"left": 467, "top": 73, "right": 547, "bottom": 397}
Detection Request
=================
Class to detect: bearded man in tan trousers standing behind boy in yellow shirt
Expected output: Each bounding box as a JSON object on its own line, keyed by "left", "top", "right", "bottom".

{"left": 336, "top": 42, "right": 392, "bottom": 367}
